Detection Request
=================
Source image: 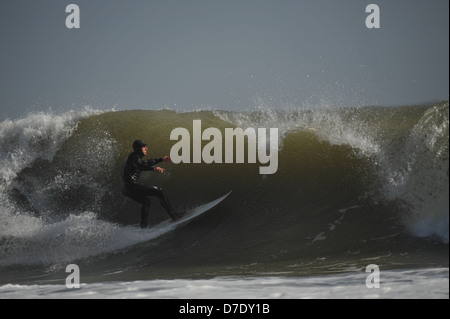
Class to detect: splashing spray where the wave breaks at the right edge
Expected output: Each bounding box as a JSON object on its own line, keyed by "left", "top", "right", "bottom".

{"left": 383, "top": 103, "right": 449, "bottom": 243}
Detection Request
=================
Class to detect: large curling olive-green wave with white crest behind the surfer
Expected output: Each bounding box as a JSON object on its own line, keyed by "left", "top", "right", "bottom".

{"left": 0, "top": 102, "right": 449, "bottom": 280}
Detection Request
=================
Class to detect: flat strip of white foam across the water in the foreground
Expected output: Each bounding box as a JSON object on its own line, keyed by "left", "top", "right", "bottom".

{"left": 0, "top": 268, "right": 449, "bottom": 303}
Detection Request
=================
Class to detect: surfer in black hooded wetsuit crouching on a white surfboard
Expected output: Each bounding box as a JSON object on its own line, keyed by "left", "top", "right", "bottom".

{"left": 121, "top": 140, "right": 177, "bottom": 228}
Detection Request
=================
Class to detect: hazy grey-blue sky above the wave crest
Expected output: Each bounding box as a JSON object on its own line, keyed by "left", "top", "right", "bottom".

{"left": 0, "top": 0, "right": 449, "bottom": 120}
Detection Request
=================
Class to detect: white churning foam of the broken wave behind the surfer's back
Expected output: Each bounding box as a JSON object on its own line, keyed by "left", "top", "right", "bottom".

{"left": 0, "top": 108, "right": 126, "bottom": 266}
